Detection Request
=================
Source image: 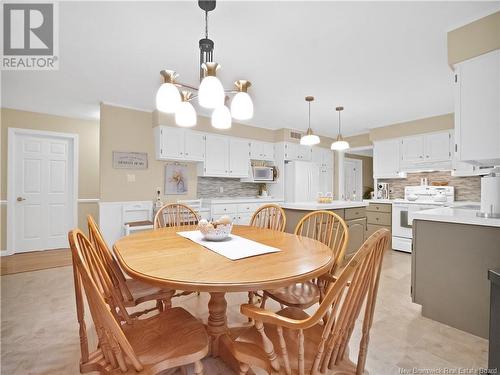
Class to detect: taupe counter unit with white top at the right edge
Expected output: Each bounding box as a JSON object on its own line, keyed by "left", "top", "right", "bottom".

{"left": 410, "top": 207, "right": 500, "bottom": 338}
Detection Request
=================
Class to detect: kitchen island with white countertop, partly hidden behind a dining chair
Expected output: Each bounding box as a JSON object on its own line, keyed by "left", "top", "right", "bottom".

{"left": 281, "top": 201, "right": 368, "bottom": 264}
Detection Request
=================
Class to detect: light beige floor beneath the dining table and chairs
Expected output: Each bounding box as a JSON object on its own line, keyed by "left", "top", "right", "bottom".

{"left": 0, "top": 251, "right": 487, "bottom": 375}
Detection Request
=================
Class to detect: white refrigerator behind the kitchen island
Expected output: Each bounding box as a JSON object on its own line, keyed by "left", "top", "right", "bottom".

{"left": 285, "top": 161, "right": 319, "bottom": 202}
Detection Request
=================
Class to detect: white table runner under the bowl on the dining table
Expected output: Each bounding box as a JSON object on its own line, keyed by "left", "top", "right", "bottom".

{"left": 177, "top": 230, "right": 281, "bottom": 260}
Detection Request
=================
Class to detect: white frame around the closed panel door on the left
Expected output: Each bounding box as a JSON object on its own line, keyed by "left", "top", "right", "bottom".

{"left": 6, "top": 128, "right": 78, "bottom": 255}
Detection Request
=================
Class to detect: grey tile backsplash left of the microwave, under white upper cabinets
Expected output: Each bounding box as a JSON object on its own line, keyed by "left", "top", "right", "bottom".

{"left": 198, "top": 177, "right": 259, "bottom": 198}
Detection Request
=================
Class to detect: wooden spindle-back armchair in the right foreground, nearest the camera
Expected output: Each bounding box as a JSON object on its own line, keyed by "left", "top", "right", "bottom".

{"left": 231, "top": 229, "right": 390, "bottom": 375}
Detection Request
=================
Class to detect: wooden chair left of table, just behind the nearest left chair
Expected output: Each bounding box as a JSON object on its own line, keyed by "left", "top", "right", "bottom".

{"left": 87, "top": 215, "right": 175, "bottom": 317}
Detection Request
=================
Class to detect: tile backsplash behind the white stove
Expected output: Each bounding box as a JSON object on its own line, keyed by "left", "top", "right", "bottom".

{"left": 377, "top": 172, "right": 481, "bottom": 202}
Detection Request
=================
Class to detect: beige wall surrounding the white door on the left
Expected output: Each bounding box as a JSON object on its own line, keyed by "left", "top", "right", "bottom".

{"left": 0, "top": 108, "right": 99, "bottom": 250}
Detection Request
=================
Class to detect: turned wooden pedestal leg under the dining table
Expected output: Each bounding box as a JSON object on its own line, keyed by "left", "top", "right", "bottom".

{"left": 207, "top": 292, "right": 229, "bottom": 357}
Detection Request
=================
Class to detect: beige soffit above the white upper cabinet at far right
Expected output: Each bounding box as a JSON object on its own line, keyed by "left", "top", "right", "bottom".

{"left": 448, "top": 12, "right": 500, "bottom": 66}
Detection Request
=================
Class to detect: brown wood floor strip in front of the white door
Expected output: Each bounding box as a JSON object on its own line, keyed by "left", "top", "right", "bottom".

{"left": 0, "top": 249, "right": 71, "bottom": 276}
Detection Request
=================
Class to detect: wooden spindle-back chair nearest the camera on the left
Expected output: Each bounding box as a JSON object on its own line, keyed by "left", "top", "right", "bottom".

{"left": 68, "top": 229, "right": 208, "bottom": 374}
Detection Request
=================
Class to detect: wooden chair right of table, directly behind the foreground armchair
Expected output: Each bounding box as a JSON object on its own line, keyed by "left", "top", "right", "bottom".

{"left": 261, "top": 211, "right": 349, "bottom": 309}
